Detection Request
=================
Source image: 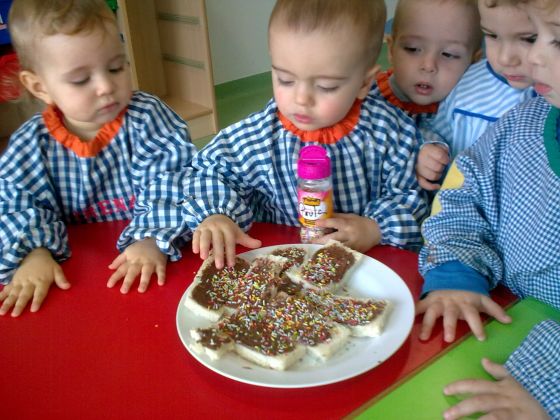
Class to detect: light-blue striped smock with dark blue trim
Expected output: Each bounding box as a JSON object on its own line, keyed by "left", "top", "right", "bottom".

{"left": 430, "top": 59, "right": 536, "bottom": 158}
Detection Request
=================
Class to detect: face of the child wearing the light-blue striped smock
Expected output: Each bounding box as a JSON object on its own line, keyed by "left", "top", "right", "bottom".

{"left": 478, "top": 0, "right": 535, "bottom": 89}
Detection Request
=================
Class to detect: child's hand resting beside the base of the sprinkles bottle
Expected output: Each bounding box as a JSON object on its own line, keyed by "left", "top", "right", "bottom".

{"left": 313, "top": 213, "right": 381, "bottom": 252}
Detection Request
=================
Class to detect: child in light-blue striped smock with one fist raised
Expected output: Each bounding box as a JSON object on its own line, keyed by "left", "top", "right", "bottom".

{"left": 416, "top": 0, "right": 535, "bottom": 190}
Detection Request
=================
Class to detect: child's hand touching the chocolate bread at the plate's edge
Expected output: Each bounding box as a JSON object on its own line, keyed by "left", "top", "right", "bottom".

{"left": 192, "top": 214, "right": 261, "bottom": 269}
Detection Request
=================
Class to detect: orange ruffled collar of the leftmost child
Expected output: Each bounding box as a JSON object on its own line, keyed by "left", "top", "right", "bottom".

{"left": 43, "top": 106, "right": 126, "bottom": 158}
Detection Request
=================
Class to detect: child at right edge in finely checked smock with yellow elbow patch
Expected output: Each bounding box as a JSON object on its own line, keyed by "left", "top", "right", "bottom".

{"left": 417, "top": 0, "right": 560, "bottom": 419}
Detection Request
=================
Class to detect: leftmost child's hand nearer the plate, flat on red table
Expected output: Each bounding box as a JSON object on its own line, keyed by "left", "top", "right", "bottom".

{"left": 107, "top": 238, "right": 167, "bottom": 293}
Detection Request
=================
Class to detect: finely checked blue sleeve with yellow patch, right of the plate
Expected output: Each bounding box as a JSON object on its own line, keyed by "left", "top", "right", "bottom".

{"left": 419, "top": 110, "right": 514, "bottom": 289}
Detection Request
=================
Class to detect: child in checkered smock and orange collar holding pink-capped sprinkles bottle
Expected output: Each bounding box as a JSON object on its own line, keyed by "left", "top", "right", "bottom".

{"left": 180, "top": 0, "right": 427, "bottom": 267}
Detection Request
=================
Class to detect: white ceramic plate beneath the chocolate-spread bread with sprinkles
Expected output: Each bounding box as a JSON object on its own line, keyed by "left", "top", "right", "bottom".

{"left": 177, "top": 244, "right": 414, "bottom": 388}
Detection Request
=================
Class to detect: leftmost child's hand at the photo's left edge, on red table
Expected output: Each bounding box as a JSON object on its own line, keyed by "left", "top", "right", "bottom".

{"left": 0, "top": 248, "right": 70, "bottom": 316}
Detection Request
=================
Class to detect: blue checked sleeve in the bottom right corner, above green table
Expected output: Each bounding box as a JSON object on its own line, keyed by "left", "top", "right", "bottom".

{"left": 505, "top": 320, "right": 560, "bottom": 419}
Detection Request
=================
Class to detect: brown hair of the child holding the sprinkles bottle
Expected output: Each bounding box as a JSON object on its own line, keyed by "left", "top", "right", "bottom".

{"left": 269, "top": 0, "right": 387, "bottom": 64}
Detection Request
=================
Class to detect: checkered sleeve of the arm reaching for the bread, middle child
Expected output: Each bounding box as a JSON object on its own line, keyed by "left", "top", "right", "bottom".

{"left": 183, "top": 110, "right": 274, "bottom": 231}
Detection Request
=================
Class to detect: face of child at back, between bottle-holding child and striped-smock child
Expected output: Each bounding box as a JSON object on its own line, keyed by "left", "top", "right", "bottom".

{"left": 389, "top": 1, "right": 474, "bottom": 105}
